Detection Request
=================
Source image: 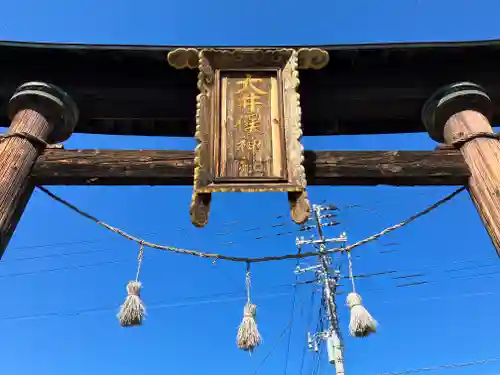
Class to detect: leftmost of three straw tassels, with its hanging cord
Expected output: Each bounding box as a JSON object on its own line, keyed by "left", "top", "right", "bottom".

{"left": 118, "top": 244, "right": 146, "bottom": 327}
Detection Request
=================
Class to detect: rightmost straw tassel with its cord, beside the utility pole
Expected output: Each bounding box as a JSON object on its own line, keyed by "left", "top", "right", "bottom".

{"left": 346, "top": 251, "right": 377, "bottom": 337}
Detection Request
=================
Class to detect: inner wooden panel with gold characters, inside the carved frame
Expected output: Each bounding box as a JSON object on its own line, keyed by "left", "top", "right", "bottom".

{"left": 220, "top": 71, "right": 287, "bottom": 184}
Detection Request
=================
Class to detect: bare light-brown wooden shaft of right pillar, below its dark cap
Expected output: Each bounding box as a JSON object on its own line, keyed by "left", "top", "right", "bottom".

{"left": 444, "top": 111, "right": 500, "bottom": 255}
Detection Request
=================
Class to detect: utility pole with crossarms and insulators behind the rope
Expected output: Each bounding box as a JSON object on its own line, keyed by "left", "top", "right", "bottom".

{"left": 295, "top": 205, "right": 347, "bottom": 375}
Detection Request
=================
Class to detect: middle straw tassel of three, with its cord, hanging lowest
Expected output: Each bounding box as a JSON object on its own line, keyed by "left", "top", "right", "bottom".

{"left": 236, "top": 263, "right": 261, "bottom": 353}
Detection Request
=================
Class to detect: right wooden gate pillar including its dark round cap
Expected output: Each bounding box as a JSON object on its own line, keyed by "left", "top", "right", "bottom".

{"left": 422, "top": 82, "right": 500, "bottom": 255}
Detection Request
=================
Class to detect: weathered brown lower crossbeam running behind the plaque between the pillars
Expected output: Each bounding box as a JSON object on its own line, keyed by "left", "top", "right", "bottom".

{"left": 32, "top": 149, "right": 469, "bottom": 186}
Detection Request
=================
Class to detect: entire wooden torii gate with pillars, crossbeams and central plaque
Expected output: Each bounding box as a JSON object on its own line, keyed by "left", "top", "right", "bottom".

{"left": 0, "top": 41, "right": 500, "bottom": 256}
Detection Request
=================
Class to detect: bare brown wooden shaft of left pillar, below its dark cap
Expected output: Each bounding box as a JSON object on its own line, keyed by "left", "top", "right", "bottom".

{"left": 0, "top": 109, "right": 52, "bottom": 258}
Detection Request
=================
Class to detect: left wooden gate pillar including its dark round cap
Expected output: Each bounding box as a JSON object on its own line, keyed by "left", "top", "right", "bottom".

{"left": 0, "top": 82, "right": 78, "bottom": 258}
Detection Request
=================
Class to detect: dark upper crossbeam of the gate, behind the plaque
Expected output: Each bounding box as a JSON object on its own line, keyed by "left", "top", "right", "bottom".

{"left": 0, "top": 41, "right": 500, "bottom": 136}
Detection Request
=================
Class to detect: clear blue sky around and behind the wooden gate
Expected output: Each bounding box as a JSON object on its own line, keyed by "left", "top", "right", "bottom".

{"left": 0, "top": 0, "right": 500, "bottom": 375}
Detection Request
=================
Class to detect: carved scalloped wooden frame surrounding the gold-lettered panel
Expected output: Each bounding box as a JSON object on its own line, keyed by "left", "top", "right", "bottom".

{"left": 167, "top": 48, "right": 328, "bottom": 227}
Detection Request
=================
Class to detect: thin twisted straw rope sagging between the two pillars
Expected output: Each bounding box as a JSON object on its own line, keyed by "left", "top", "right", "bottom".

{"left": 37, "top": 186, "right": 465, "bottom": 263}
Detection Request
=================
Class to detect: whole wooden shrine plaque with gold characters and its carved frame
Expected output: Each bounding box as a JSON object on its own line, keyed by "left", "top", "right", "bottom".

{"left": 167, "top": 48, "right": 329, "bottom": 227}
